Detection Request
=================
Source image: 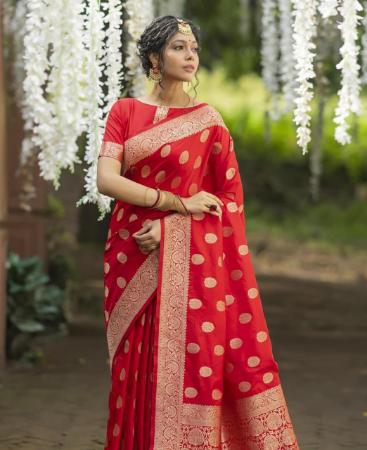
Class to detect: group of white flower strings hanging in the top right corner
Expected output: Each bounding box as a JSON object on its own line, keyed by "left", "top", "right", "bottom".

{"left": 262, "top": 0, "right": 367, "bottom": 154}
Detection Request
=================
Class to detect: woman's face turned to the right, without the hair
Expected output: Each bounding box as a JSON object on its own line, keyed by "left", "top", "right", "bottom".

{"left": 163, "top": 32, "right": 199, "bottom": 81}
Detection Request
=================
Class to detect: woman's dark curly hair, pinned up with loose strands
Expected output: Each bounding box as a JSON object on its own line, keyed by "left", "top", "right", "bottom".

{"left": 137, "top": 15, "right": 201, "bottom": 97}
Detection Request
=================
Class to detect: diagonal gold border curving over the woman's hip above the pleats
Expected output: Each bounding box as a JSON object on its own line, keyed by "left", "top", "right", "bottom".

{"left": 107, "top": 248, "right": 159, "bottom": 368}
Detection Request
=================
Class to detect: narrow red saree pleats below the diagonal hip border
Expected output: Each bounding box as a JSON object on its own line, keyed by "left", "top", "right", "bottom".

{"left": 105, "top": 296, "right": 157, "bottom": 450}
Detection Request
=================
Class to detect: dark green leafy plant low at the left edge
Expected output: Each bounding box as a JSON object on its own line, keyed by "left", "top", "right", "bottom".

{"left": 6, "top": 252, "right": 66, "bottom": 359}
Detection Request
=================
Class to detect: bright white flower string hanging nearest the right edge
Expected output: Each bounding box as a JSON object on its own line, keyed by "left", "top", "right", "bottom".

{"left": 334, "top": 0, "right": 363, "bottom": 145}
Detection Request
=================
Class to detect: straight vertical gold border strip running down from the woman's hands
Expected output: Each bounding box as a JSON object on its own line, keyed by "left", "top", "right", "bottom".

{"left": 154, "top": 214, "right": 191, "bottom": 450}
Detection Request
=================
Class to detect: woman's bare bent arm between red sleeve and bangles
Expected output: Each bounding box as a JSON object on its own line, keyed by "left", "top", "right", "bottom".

{"left": 97, "top": 156, "right": 157, "bottom": 206}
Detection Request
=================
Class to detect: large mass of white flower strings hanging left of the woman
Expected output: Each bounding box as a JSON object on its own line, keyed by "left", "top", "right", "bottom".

{"left": 4, "top": 0, "right": 129, "bottom": 220}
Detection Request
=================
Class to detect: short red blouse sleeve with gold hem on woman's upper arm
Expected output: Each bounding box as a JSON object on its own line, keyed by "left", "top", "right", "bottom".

{"left": 98, "top": 100, "right": 127, "bottom": 163}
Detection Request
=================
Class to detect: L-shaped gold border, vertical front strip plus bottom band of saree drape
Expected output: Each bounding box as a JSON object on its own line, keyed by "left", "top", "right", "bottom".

{"left": 152, "top": 214, "right": 299, "bottom": 450}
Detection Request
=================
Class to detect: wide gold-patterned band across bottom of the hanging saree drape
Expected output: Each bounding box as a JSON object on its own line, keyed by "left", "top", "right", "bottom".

{"left": 180, "top": 384, "right": 299, "bottom": 450}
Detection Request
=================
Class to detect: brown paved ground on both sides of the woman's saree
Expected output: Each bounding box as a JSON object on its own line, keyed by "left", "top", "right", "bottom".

{"left": 0, "top": 276, "right": 367, "bottom": 450}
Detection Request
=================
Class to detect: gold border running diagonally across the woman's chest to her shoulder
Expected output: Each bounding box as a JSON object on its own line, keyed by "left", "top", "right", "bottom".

{"left": 124, "top": 105, "right": 227, "bottom": 172}
